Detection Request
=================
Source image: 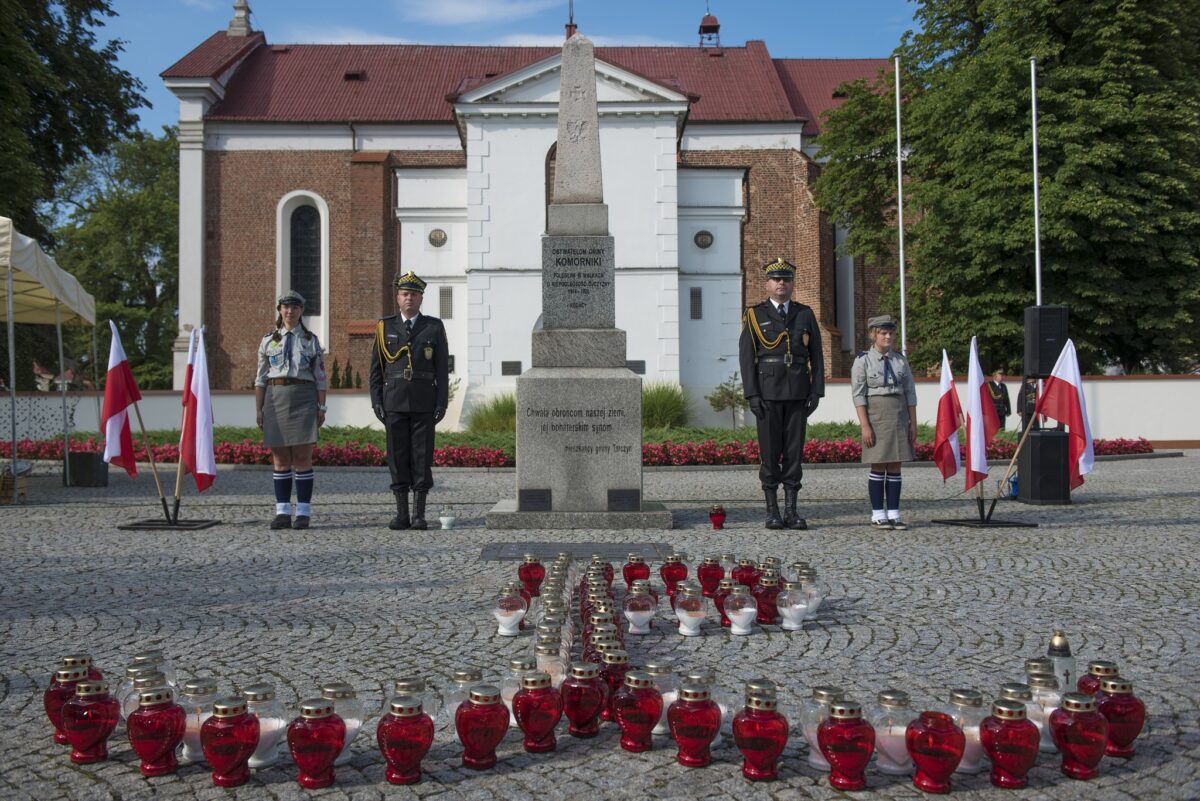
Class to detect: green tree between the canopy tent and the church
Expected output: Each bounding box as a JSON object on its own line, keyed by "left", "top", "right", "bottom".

{"left": 54, "top": 128, "right": 179, "bottom": 389}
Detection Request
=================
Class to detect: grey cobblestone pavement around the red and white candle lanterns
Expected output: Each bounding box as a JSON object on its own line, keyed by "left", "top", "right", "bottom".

{"left": 0, "top": 452, "right": 1200, "bottom": 801}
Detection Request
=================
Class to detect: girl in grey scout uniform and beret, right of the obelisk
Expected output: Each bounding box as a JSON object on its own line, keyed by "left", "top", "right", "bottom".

{"left": 850, "top": 314, "right": 917, "bottom": 530}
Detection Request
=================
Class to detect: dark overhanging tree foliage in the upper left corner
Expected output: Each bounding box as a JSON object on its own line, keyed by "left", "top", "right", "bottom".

{"left": 0, "top": 0, "right": 145, "bottom": 245}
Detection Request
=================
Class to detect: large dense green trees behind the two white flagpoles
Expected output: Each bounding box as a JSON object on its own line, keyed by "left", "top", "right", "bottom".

{"left": 816, "top": 0, "right": 1200, "bottom": 372}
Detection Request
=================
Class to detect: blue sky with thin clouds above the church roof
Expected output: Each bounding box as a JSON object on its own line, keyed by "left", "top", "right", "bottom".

{"left": 110, "top": 0, "right": 916, "bottom": 132}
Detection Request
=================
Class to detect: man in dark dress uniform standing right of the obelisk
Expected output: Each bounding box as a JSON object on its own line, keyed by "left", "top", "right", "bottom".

{"left": 738, "top": 259, "right": 824, "bottom": 529}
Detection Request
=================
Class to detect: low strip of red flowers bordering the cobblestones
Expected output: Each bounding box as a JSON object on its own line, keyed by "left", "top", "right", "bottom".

{"left": 0, "top": 438, "right": 1154, "bottom": 468}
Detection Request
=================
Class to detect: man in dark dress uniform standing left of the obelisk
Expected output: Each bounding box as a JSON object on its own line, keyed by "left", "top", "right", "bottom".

{"left": 371, "top": 272, "right": 450, "bottom": 531}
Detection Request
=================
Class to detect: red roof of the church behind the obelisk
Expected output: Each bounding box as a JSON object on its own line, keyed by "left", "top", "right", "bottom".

{"left": 162, "top": 32, "right": 887, "bottom": 131}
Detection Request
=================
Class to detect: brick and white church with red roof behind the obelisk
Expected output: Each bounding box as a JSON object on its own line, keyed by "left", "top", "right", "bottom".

{"left": 162, "top": 0, "right": 895, "bottom": 424}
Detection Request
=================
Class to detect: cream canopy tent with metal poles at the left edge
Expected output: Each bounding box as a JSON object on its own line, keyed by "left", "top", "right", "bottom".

{"left": 0, "top": 217, "right": 96, "bottom": 504}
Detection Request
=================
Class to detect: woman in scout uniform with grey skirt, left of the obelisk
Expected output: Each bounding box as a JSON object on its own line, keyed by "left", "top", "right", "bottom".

{"left": 254, "top": 291, "right": 326, "bottom": 529}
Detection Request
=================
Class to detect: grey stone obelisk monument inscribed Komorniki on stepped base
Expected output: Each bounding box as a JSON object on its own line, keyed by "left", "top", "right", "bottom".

{"left": 487, "top": 34, "right": 671, "bottom": 529}
